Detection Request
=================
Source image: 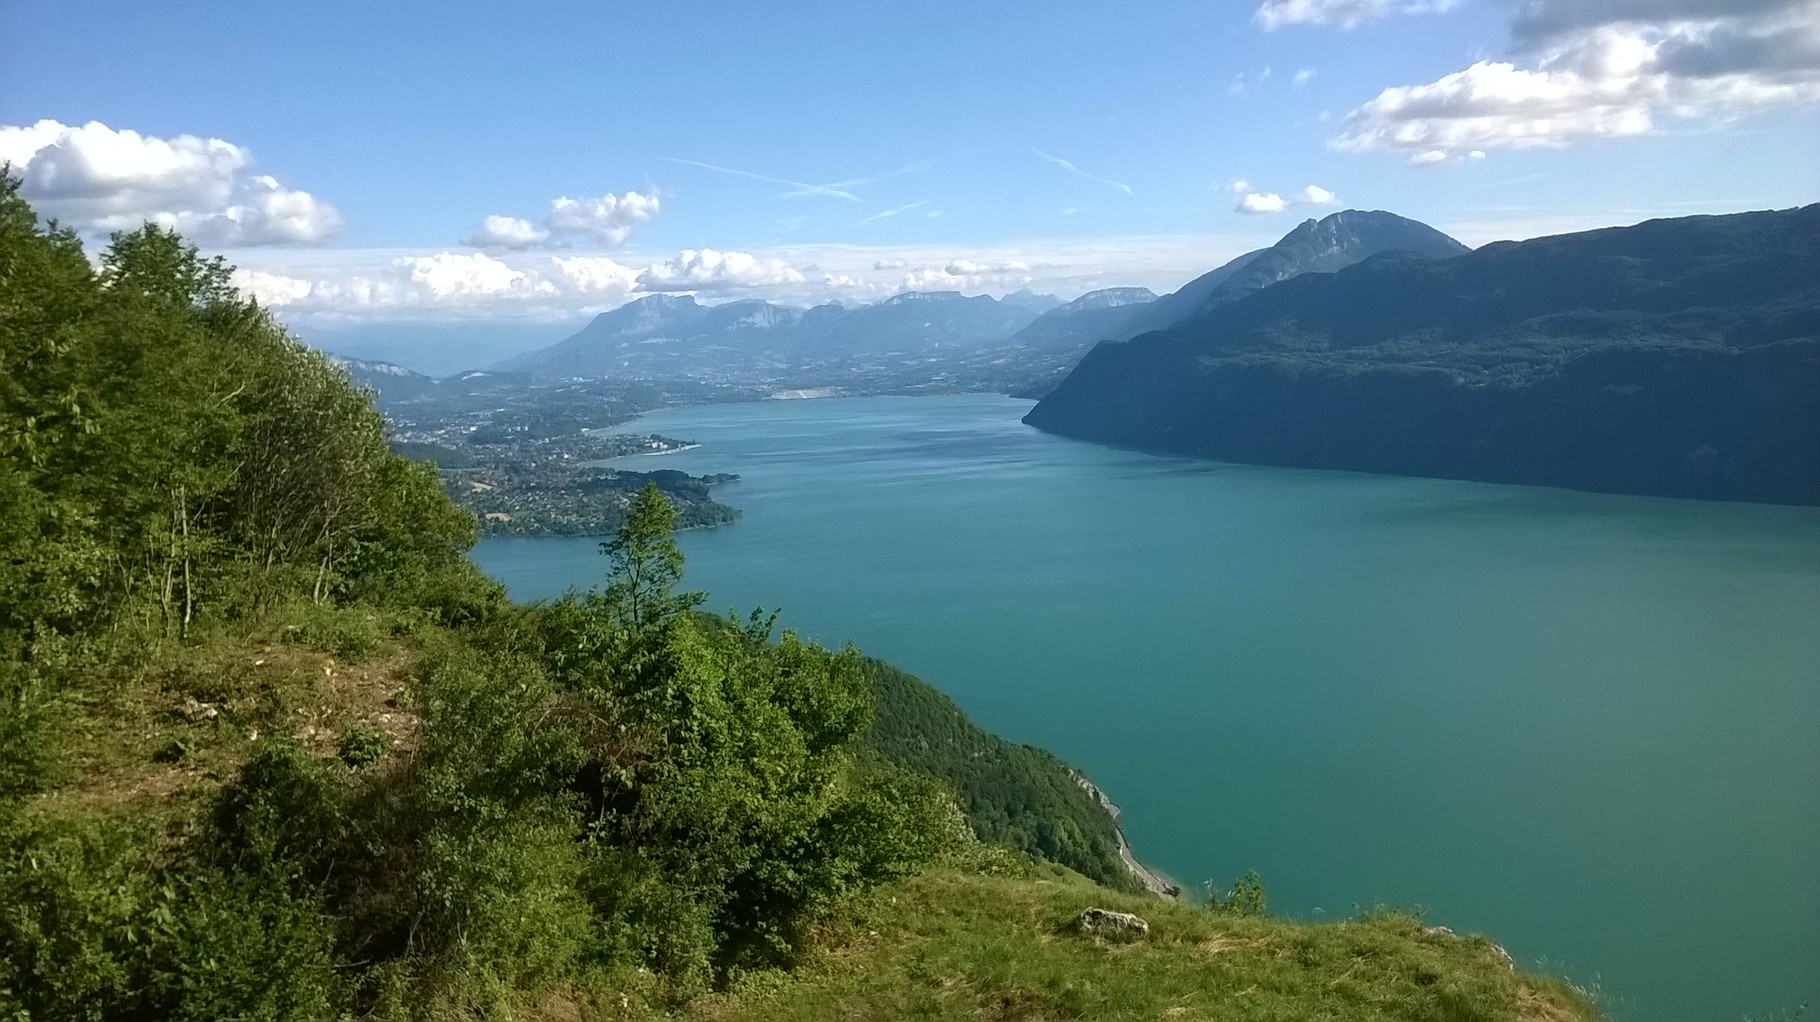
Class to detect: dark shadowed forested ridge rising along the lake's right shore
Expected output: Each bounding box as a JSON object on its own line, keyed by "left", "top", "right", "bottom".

{"left": 1025, "top": 205, "right": 1820, "bottom": 504}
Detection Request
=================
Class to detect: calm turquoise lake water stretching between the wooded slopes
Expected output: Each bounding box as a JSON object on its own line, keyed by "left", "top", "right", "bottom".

{"left": 475, "top": 396, "right": 1820, "bottom": 1020}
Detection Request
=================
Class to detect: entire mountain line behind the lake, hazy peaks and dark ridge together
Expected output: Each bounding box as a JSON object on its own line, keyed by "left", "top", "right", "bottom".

{"left": 334, "top": 205, "right": 1820, "bottom": 504}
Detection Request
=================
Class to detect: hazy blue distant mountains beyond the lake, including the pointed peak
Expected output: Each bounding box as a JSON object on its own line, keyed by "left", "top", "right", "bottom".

{"left": 469, "top": 209, "right": 1467, "bottom": 389}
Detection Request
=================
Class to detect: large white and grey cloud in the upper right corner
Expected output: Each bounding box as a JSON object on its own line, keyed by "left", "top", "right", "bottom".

{"left": 1334, "top": 0, "right": 1820, "bottom": 158}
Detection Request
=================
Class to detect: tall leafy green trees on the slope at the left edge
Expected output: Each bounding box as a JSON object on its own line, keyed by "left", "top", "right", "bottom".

{"left": 0, "top": 163, "right": 475, "bottom": 655}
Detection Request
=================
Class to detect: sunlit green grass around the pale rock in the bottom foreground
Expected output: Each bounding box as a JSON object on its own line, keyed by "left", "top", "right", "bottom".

{"left": 684, "top": 867, "right": 1598, "bottom": 1022}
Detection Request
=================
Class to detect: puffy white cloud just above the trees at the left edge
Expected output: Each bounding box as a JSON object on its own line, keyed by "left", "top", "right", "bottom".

{"left": 0, "top": 120, "right": 342, "bottom": 245}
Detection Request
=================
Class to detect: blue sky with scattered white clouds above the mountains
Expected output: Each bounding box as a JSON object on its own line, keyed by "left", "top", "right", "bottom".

{"left": 0, "top": 0, "right": 1820, "bottom": 361}
